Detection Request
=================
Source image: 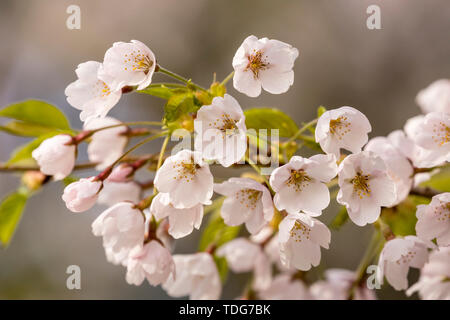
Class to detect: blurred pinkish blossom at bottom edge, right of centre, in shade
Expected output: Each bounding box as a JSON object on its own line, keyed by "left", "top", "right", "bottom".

{"left": 310, "top": 269, "right": 375, "bottom": 300}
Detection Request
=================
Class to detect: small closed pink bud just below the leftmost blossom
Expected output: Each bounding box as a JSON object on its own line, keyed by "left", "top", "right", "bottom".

{"left": 62, "top": 177, "right": 102, "bottom": 212}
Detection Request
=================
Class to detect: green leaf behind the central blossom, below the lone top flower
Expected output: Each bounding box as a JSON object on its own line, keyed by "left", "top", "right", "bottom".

{"left": 244, "top": 108, "right": 299, "bottom": 138}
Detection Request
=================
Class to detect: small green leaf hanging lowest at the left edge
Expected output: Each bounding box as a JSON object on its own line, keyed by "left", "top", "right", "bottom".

{"left": 0, "top": 191, "right": 28, "bottom": 247}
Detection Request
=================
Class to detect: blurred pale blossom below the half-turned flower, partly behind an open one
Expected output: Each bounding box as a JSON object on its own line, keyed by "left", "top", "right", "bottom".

{"left": 216, "top": 238, "right": 272, "bottom": 290}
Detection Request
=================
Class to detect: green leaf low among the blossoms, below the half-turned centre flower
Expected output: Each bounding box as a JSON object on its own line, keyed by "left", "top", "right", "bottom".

{"left": 199, "top": 210, "right": 240, "bottom": 251}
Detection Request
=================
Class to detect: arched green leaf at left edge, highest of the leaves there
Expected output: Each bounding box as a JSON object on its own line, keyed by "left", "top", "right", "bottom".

{"left": 0, "top": 100, "right": 70, "bottom": 130}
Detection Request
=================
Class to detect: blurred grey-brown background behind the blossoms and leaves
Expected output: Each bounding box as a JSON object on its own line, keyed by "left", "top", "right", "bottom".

{"left": 0, "top": 0, "right": 450, "bottom": 299}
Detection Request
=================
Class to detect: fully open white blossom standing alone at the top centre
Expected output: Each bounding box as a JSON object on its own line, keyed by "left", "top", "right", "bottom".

{"left": 233, "top": 36, "right": 298, "bottom": 97}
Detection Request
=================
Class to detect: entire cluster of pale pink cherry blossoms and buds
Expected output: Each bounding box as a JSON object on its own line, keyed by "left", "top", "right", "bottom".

{"left": 26, "top": 36, "right": 450, "bottom": 299}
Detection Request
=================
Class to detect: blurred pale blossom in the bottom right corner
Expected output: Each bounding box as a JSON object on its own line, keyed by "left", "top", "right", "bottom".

{"left": 406, "top": 247, "right": 450, "bottom": 300}
